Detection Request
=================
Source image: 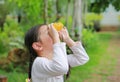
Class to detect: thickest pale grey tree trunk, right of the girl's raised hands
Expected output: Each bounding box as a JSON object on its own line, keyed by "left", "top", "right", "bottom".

{"left": 72, "top": 0, "right": 82, "bottom": 40}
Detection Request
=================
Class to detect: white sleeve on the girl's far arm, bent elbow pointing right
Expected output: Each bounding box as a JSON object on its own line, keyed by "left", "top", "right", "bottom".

{"left": 67, "top": 42, "right": 89, "bottom": 67}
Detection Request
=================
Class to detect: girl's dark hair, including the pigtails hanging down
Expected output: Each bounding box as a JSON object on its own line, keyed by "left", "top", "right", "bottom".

{"left": 24, "top": 24, "right": 70, "bottom": 79}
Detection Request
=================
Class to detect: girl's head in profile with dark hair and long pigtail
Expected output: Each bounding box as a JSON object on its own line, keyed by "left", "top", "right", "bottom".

{"left": 25, "top": 25, "right": 53, "bottom": 78}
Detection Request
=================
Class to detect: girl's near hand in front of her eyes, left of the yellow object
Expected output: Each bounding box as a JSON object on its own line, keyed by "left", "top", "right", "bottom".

{"left": 48, "top": 24, "right": 60, "bottom": 43}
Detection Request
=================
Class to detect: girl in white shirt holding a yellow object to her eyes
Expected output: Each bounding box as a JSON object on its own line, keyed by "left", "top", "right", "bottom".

{"left": 25, "top": 24, "right": 89, "bottom": 82}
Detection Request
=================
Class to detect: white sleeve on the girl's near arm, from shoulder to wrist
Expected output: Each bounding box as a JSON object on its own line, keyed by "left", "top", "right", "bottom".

{"left": 33, "top": 43, "right": 68, "bottom": 78}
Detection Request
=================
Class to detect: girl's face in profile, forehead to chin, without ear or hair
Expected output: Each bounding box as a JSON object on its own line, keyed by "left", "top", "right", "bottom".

{"left": 39, "top": 25, "right": 53, "bottom": 52}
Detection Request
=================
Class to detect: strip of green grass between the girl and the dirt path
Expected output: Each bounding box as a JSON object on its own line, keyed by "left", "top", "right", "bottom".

{"left": 67, "top": 33, "right": 112, "bottom": 82}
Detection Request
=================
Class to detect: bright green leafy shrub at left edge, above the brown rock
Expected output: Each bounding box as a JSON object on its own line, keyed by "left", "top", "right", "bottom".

{"left": 0, "top": 17, "right": 23, "bottom": 53}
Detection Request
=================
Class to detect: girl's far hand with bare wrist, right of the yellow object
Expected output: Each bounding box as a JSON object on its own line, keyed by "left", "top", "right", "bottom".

{"left": 59, "top": 28, "right": 75, "bottom": 47}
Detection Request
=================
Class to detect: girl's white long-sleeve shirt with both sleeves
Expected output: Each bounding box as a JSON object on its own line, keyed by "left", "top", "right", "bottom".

{"left": 32, "top": 42, "right": 89, "bottom": 82}
